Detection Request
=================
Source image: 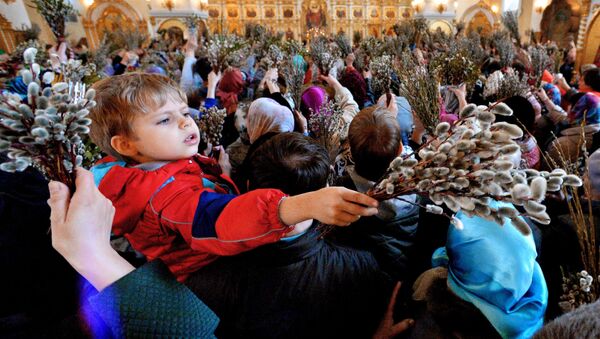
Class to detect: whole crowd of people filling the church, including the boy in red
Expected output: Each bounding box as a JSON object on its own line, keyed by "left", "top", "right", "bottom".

{"left": 0, "top": 19, "right": 600, "bottom": 338}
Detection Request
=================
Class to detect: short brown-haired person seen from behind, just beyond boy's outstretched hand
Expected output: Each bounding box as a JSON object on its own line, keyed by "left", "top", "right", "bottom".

{"left": 332, "top": 105, "right": 419, "bottom": 280}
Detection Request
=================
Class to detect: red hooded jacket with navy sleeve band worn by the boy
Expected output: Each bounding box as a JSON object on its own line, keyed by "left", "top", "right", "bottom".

{"left": 92, "top": 155, "right": 292, "bottom": 281}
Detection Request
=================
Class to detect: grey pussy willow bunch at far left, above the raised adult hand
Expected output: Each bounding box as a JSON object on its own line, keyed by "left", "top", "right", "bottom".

{"left": 0, "top": 48, "right": 96, "bottom": 189}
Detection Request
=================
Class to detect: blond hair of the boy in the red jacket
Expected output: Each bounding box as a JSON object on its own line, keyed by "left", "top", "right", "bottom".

{"left": 89, "top": 73, "right": 187, "bottom": 160}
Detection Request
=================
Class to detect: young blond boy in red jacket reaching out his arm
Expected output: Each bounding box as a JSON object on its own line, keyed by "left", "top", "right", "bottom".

{"left": 90, "top": 74, "right": 377, "bottom": 281}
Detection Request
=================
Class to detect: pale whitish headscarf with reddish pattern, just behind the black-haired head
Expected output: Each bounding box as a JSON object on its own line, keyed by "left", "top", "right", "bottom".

{"left": 246, "top": 98, "right": 294, "bottom": 144}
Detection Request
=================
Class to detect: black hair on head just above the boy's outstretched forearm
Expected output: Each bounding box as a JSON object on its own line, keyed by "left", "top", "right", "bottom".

{"left": 247, "top": 132, "right": 330, "bottom": 195}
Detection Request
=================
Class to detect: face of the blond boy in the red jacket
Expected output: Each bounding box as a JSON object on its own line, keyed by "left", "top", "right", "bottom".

{"left": 116, "top": 100, "right": 200, "bottom": 163}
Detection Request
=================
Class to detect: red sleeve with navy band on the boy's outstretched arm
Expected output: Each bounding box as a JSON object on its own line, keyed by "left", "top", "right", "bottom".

{"left": 151, "top": 185, "right": 292, "bottom": 255}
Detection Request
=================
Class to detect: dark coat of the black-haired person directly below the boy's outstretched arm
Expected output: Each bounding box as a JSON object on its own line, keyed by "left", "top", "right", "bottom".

{"left": 186, "top": 226, "right": 392, "bottom": 338}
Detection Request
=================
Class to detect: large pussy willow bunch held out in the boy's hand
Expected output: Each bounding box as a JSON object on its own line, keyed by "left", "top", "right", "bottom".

{"left": 368, "top": 103, "right": 582, "bottom": 234}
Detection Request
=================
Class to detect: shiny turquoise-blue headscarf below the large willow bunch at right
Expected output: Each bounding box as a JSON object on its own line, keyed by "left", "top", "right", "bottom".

{"left": 432, "top": 201, "right": 548, "bottom": 339}
